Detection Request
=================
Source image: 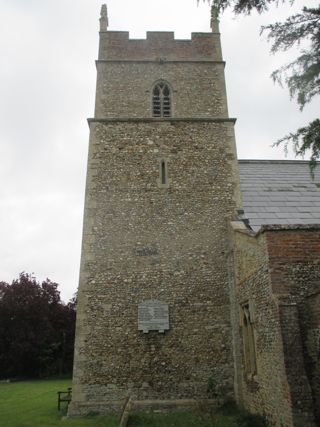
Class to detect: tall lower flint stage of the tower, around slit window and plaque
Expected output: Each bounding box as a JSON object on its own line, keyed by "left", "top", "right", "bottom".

{"left": 71, "top": 121, "right": 237, "bottom": 414}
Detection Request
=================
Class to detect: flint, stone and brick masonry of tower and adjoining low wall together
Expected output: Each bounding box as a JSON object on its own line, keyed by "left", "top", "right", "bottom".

{"left": 69, "top": 5, "right": 320, "bottom": 427}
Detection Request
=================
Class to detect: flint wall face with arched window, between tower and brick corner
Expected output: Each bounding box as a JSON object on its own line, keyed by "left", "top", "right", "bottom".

{"left": 232, "top": 227, "right": 293, "bottom": 427}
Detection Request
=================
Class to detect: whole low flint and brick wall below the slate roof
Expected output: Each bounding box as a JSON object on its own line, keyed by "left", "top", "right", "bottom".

{"left": 234, "top": 226, "right": 320, "bottom": 427}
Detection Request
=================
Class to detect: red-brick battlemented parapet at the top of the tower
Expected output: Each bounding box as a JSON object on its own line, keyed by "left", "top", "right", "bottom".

{"left": 99, "top": 31, "right": 222, "bottom": 61}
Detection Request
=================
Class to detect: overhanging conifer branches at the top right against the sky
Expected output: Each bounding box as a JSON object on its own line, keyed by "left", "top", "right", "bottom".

{"left": 205, "top": 0, "right": 320, "bottom": 173}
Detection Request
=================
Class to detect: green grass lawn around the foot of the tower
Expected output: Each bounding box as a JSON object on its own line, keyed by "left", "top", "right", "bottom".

{"left": 0, "top": 379, "right": 241, "bottom": 427}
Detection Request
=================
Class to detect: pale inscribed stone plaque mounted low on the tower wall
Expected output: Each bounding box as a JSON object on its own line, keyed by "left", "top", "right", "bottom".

{"left": 138, "top": 299, "right": 169, "bottom": 334}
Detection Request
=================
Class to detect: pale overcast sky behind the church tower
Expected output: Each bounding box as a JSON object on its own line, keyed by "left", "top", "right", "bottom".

{"left": 0, "top": 0, "right": 320, "bottom": 301}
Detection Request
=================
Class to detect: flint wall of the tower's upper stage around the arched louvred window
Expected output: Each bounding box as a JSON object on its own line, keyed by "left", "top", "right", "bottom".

{"left": 95, "top": 61, "right": 228, "bottom": 118}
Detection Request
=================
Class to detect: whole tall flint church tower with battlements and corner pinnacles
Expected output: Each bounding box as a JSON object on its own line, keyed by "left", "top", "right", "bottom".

{"left": 69, "top": 5, "right": 240, "bottom": 415}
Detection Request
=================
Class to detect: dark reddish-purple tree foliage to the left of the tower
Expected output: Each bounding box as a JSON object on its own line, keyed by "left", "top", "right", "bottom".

{"left": 0, "top": 273, "right": 75, "bottom": 378}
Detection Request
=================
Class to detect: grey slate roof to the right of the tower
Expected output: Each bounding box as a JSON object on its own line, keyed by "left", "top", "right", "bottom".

{"left": 239, "top": 160, "right": 320, "bottom": 231}
